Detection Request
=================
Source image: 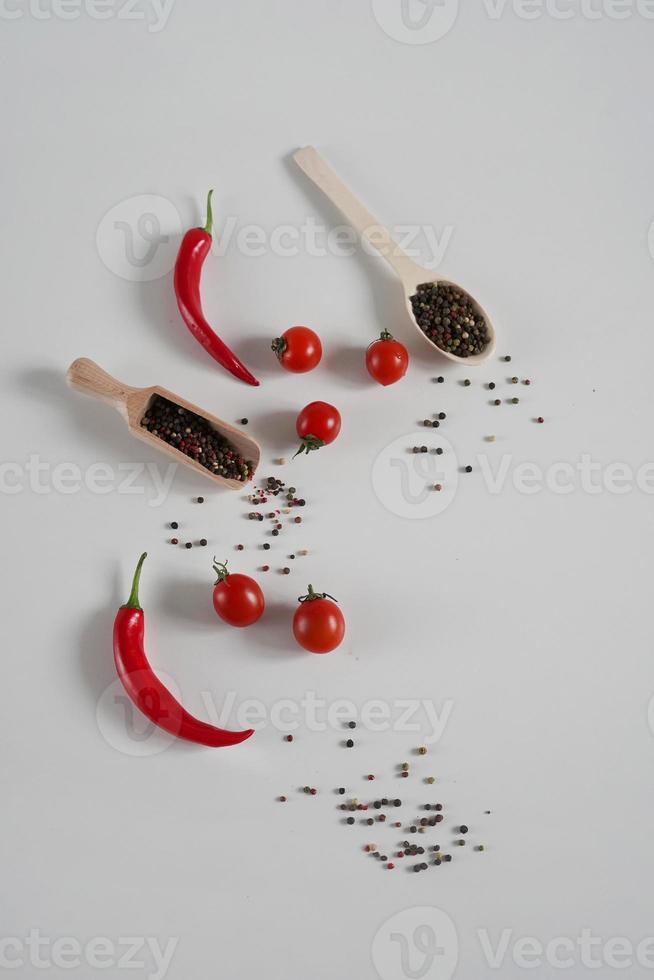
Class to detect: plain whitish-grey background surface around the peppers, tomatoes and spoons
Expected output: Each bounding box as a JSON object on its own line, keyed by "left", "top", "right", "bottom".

{"left": 0, "top": 0, "right": 654, "bottom": 980}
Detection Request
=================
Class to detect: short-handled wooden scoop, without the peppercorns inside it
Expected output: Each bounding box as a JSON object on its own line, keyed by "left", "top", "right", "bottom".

{"left": 66, "top": 357, "right": 261, "bottom": 490}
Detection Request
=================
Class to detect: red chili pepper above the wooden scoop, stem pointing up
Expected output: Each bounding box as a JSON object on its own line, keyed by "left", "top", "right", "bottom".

{"left": 174, "top": 191, "right": 259, "bottom": 385}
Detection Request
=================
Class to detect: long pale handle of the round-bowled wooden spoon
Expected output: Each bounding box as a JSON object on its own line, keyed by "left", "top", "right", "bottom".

{"left": 293, "top": 146, "right": 420, "bottom": 285}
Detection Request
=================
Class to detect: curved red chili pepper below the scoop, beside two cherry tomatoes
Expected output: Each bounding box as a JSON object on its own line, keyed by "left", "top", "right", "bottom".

{"left": 114, "top": 553, "right": 254, "bottom": 747}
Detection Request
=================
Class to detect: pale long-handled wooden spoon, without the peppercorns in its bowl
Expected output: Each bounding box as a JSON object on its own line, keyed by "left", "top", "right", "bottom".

{"left": 293, "top": 146, "right": 495, "bottom": 365}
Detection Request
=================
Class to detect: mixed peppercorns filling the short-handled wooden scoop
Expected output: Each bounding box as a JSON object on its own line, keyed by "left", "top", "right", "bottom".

{"left": 141, "top": 395, "right": 253, "bottom": 483}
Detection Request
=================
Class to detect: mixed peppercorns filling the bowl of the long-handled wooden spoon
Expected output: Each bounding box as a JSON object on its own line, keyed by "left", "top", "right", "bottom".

{"left": 411, "top": 282, "right": 490, "bottom": 357}
